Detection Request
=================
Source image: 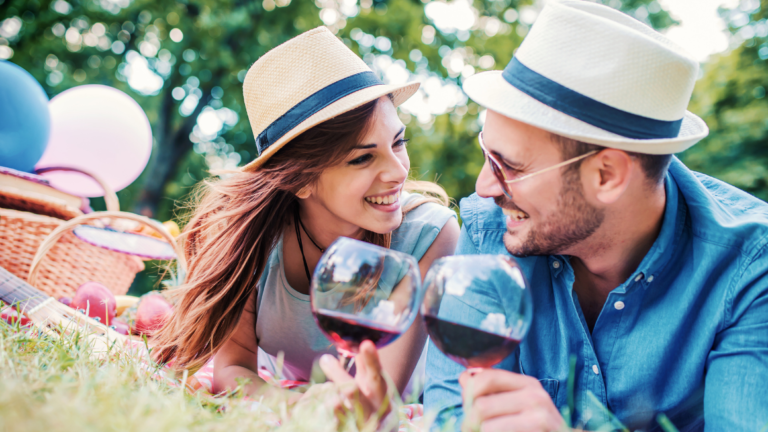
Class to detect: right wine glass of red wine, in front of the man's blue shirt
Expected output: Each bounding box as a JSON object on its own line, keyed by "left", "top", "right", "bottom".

{"left": 421, "top": 255, "right": 533, "bottom": 368}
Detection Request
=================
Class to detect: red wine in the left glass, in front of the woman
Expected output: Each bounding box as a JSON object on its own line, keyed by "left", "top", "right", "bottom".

{"left": 315, "top": 310, "right": 402, "bottom": 354}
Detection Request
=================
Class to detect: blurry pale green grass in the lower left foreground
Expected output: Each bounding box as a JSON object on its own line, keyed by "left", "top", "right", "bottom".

{"left": 0, "top": 322, "right": 373, "bottom": 432}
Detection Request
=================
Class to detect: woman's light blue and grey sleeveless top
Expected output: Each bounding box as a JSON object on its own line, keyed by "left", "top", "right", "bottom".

{"left": 256, "top": 192, "right": 456, "bottom": 381}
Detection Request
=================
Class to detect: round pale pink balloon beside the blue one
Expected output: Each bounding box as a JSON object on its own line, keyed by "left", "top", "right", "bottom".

{"left": 36, "top": 85, "right": 152, "bottom": 197}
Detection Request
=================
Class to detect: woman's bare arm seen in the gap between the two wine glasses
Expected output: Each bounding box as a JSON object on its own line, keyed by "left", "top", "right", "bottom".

{"left": 379, "top": 218, "right": 459, "bottom": 394}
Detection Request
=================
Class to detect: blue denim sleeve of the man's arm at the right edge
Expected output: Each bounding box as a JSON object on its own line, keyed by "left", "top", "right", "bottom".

{"left": 704, "top": 247, "right": 768, "bottom": 431}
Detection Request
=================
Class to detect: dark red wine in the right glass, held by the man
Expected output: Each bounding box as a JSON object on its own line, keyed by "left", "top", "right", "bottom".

{"left": 424, "top": 315, "right": 520, "bottom": 367}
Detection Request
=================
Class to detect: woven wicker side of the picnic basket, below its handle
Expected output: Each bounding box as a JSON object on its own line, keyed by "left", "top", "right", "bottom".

{"left": 0, "top": 208, "right": 144, "bottom": 298}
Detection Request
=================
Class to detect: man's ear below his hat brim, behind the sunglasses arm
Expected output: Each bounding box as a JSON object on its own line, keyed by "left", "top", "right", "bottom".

{"left": 581, "top": 149, "right": 635, "bottom": 204}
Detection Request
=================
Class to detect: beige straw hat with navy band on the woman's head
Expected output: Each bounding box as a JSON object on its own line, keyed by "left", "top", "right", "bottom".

{"left": 242, "top": 27, "right": 419, "bottom": 171}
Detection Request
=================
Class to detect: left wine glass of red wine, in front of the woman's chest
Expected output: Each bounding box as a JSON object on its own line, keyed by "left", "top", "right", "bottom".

{"left": 310, "top": 237, "right": 423, "bottom": 369}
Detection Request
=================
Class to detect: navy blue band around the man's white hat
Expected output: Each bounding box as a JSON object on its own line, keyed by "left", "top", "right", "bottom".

{"left": 501, "top": 57, "right": 683, "bottom": 139}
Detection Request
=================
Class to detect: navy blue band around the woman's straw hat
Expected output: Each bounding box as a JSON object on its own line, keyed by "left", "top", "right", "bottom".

{"left": 256, "top": 71, "right": 384, "bottom": 155}
